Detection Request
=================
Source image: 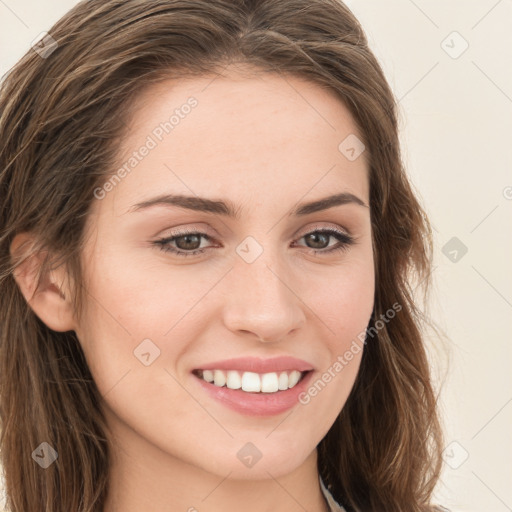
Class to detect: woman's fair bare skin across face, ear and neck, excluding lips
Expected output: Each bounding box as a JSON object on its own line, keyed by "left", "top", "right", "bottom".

{"left": 13, "top": 68, "right": 374, "bottom": 512}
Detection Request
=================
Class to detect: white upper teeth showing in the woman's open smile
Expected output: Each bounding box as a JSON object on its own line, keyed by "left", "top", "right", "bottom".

{"left": 199, "top": 370, "right": 302, "bottom": 393}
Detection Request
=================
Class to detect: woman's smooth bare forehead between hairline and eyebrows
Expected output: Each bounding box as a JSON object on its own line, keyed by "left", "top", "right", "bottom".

{"left": 97, "top": 70, "right": 369, "bottom": 218}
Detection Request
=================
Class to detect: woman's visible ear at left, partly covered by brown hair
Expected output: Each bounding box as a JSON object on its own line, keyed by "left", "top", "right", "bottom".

{"left": 10, "top": 233, "right": 75, "bottom": 332}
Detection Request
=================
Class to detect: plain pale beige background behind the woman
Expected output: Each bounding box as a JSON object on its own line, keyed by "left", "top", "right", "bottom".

{"left": 0, "top": 0, "right": 512, "bottom": 512}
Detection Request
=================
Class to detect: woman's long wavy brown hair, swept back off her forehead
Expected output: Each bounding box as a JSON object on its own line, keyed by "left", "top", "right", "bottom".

{"left": 0, "top": 0, "right": 443, "bottom": 512}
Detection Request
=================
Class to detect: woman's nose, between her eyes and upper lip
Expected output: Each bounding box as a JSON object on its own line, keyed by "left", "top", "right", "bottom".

{"left": 223, "top": 255, "right": 306, "bottom": 343}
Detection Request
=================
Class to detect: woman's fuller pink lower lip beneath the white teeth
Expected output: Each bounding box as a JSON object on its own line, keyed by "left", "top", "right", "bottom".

{"left": 193, "top": 371, "right": 313, "bottom": 416}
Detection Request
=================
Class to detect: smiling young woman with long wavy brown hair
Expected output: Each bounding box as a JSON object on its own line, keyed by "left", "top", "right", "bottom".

{"left": 0, "top": 0, "right": 442, "bottom": 512}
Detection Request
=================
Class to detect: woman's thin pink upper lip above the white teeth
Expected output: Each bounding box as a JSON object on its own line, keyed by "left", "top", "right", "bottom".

{"left": 197, "top": 356, "right": 313, "bottom": 373}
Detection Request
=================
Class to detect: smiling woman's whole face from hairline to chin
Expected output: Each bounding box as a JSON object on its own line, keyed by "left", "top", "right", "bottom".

{"left": 76, "top": 68, "right": 374, "bottom": 479}
